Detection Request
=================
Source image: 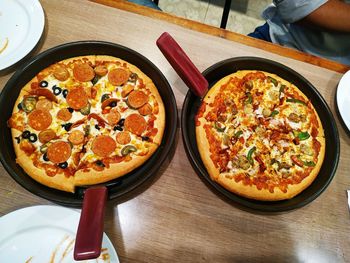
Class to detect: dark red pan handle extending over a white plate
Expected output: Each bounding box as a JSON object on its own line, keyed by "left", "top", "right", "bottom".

{"left": 74, "top": 186, "right": 107, "bottom": 260}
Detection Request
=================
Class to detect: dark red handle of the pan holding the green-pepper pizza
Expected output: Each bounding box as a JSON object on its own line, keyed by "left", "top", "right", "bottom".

{"left": 157, "top": 32, "right": 209, "bottom": 97}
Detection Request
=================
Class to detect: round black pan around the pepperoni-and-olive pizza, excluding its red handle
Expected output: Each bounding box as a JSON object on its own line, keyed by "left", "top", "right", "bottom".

{"left": 0, "top": 41, "right": 177, "bottom": 207}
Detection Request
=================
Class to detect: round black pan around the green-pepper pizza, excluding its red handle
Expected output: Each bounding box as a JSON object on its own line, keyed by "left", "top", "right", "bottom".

{"left": 181, "top": 57, "right": 340, "bottom": 212}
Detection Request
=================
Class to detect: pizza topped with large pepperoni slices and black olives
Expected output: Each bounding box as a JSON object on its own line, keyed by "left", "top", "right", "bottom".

{"left": 8, "top": 55, "right": 165, "bottom": 192}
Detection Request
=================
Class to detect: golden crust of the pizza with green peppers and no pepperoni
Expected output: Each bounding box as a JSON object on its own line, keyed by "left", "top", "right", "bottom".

{"left": 196, "top": 70, "right": 326, "bottom": 201}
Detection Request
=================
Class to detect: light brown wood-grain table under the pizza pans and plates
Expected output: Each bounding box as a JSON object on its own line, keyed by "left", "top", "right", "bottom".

{"left": 0, "top": 0, "right": 350, "bottom": 262}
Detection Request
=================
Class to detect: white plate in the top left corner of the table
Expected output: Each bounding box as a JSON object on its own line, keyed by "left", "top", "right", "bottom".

{"left": 0, "top": 0, "right": 45, "bottom": 70}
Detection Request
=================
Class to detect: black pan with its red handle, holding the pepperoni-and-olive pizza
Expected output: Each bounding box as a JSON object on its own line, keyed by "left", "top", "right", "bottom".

{"left": 0, "top": 41, "right": 177, "bottom": 260}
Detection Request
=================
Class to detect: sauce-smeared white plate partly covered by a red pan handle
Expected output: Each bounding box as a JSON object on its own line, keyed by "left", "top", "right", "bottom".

{"left": 0, "top": 206, "right": 119, "bottom": 263}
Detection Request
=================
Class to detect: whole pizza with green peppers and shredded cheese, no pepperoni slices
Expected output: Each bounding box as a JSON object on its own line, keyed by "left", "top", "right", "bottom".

{"left": 196, "top": 70, "right": 326, "bottom": 201}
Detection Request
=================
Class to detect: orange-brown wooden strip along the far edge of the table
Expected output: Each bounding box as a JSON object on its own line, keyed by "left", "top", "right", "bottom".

{"left": 90, "top": 0, "right": 350, "bottom": 73}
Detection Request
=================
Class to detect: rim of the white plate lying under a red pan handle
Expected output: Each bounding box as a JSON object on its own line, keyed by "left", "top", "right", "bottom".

{"left": 0, "top": 205, "right": 119, "bottom": 263}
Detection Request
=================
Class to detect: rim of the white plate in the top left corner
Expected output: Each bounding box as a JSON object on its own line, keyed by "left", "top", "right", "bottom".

{"left": 0, "top": 0, "right": 45, "bottom": 71}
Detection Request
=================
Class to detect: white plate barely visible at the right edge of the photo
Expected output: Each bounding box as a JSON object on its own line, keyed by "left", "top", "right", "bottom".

{"left": 337, "top": 71, "right": 350, "bottom": 130}
